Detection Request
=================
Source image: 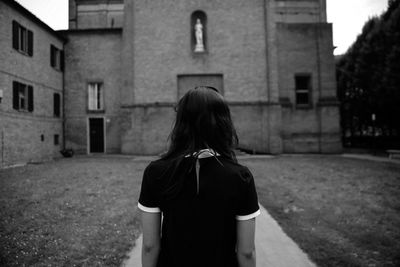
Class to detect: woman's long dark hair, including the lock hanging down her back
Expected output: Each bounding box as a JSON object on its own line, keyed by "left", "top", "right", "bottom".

{"left": 161, "top": 86, "right": 238, "bottom": 199}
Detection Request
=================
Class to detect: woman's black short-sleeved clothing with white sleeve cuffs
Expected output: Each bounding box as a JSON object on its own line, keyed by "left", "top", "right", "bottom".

{"left": 138, "top": 151, "right": 260, "bottom": 267}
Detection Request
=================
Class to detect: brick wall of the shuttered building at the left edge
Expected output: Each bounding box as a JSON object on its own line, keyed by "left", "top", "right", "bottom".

{"left": 0, "top": 1, "right": 64, "bottom": 167}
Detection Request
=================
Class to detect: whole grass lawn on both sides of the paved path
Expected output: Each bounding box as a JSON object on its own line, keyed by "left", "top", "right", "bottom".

{"left": 0, "top": 156, "right": 400, "bottom": 266}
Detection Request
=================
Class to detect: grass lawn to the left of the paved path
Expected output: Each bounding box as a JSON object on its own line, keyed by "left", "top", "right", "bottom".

{"left": 0, "top": 158, "right": 147, "bottom": 266}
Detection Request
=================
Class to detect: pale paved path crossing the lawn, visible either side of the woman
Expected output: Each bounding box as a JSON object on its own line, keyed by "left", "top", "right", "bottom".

{"left": 122, "top": 205, "right": 316, "bottom": 267}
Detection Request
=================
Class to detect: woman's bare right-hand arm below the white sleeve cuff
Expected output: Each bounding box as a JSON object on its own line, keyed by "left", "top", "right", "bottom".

{"left": 236, "top": 218, "right": 256, "bottom": 267}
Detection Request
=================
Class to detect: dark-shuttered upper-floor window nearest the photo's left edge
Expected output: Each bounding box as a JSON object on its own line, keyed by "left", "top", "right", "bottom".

{"left": 12, "top": 20, "right": 33, "bottom": 56}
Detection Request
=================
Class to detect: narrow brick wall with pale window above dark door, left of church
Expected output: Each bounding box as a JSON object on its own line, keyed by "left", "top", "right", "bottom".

{"left": 63, "top": 29, "right": 123, "bottom": 154}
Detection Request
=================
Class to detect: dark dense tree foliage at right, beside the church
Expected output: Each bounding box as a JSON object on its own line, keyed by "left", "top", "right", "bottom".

{"left": 336, "top": 0, "right": 400, "bottom": 149}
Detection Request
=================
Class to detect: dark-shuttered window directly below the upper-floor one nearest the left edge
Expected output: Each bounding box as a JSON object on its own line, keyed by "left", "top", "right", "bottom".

{"left": 13, "top": 81, "right": 33, "bottom": 112}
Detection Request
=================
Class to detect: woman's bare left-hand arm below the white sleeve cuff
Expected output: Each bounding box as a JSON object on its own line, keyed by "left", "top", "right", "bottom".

{"left": 142, "top": 211, "right": 161, "bottom": 267}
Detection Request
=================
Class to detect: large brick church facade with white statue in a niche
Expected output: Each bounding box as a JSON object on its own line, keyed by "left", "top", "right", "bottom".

{"left": 64, "top": 0, "right": 341, "bottom": 154}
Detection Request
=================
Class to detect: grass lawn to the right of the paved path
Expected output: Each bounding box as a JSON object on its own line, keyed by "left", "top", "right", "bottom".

{"left": 244, "top": 156, "right": 400, "bottom": 266}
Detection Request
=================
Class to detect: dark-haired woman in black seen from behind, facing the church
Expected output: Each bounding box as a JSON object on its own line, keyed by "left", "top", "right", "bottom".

{"left": 138, "top": 86, "right": 260, "bottom": 267}
